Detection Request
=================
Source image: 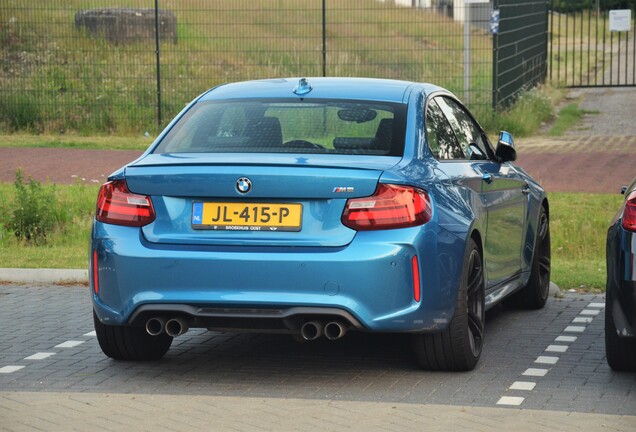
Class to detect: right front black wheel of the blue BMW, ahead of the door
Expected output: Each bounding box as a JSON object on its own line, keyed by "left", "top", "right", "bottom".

{"left": 505, "top": 206, "right": 551, "bottom": 309}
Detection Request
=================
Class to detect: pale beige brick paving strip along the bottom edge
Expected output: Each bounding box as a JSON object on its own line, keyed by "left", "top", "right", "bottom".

{"left": 0, "top": 392, "right": 636, "bottom": 432}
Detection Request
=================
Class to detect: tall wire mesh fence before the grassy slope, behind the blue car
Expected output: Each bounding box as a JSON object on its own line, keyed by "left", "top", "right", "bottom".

{"left": 0, "top": 0, "right": 545, "bottom": 133}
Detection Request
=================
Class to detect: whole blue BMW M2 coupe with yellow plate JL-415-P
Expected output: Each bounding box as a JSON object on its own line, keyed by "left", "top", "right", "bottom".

{"left": 90, "top": 78, "right": 550, "bottom": 370}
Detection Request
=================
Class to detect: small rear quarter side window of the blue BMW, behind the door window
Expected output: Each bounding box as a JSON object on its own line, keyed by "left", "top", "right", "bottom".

{"left": 426, "top": 99, "right": 465, "bottom": 160}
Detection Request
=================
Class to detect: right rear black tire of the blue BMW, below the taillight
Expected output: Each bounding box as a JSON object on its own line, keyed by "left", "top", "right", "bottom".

{"left": 412, "top": 239, "right": 485, "bottom": 371}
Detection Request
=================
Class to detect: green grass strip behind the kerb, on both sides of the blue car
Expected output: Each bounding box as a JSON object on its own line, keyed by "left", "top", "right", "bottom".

{"left": 0, "top": 183, "right": 622, "bottom": 291}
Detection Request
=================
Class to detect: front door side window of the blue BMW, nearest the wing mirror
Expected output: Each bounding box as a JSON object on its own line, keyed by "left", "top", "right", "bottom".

{"left": 435, "top": 97, "right": 488, "bottom": 159}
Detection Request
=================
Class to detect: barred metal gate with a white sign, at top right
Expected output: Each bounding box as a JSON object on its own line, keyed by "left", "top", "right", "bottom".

{"left": 549, "top": 0, "right": 636, "bottom": 87}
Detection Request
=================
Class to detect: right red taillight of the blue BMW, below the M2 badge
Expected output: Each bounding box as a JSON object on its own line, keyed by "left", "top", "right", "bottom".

{"left": 342, "top": 184, "right": 431, "bottom": 231}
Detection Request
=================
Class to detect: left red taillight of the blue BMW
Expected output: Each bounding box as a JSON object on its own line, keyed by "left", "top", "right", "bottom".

{"left": 95, "top": 180, "right": 155, "bottom": 226}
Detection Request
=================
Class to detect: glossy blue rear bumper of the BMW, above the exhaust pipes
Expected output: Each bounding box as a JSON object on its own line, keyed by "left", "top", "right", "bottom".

{"left": 89, "top": 222, "right": 464, "bottom": 332}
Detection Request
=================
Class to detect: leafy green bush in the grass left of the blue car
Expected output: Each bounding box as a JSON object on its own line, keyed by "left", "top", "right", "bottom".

{"left": 6, "top": 170, "right": 65, "bottom": 244}
